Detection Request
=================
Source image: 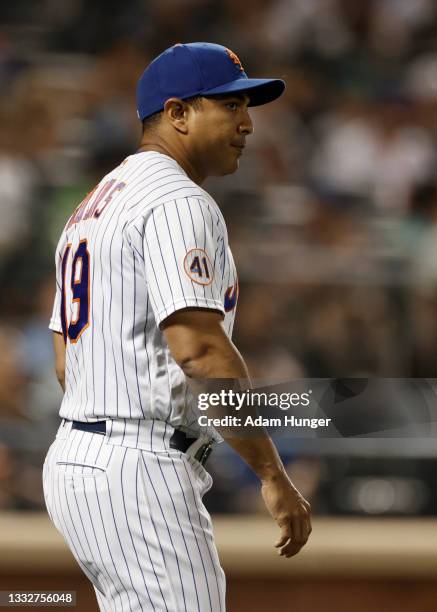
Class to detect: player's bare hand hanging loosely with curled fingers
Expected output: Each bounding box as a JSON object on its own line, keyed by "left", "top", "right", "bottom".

{"left": 261, "top": 474, "right": 312, "bottom": 558}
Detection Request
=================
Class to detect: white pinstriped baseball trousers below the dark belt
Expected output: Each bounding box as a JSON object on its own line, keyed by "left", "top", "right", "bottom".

{"left": 43, "top": 421, "right": 225, "bottom": 612}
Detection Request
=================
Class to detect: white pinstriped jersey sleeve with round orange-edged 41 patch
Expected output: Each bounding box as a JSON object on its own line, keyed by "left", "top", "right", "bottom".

{"left": 139, "top": 198, "right": 225, "bottom": 325}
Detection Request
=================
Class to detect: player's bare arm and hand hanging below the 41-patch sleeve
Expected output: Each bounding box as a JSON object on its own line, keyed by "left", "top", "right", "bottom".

{"left": 164, "top": 311, "right": 311, "bottom": 557}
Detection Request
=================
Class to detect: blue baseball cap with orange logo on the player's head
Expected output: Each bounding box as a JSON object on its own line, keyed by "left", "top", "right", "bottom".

{"left": 137, "top": 43, "right": 285, "bottom": 121}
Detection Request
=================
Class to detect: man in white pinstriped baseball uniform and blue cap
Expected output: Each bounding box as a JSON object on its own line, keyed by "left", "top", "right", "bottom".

{"left": 44, "top": 43, "right": 311, "bottom": 612}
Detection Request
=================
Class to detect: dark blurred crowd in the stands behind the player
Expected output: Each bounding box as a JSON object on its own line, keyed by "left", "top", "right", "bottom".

{"left": 0, "top": 0, "right": 437, "bottom": 513}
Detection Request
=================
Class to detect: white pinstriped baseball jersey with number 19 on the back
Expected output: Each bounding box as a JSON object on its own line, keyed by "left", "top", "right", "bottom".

{"left": 49, "top": 152, "right": 238, "bottom": 437}
